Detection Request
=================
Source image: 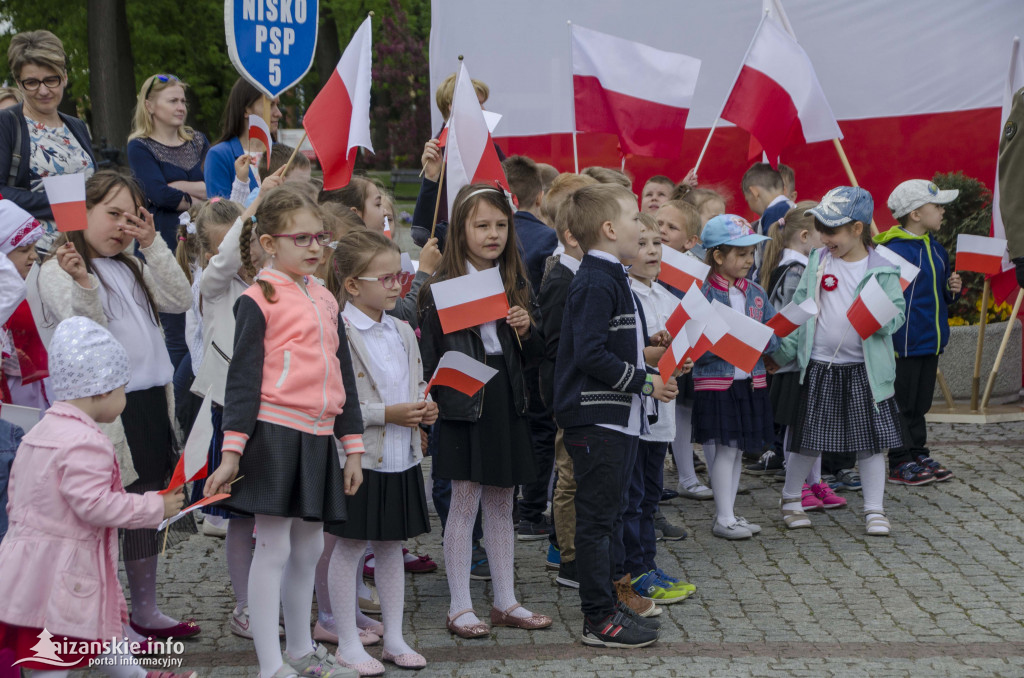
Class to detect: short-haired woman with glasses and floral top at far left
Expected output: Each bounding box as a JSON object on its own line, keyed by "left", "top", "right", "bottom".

{"left": 0, "top": 31, "right": 96, "bottom": 252}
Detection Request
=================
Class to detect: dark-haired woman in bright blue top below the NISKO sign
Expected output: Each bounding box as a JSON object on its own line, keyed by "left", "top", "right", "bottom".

{"left": 204, "top": 78, "right": 282, "bottom": 198}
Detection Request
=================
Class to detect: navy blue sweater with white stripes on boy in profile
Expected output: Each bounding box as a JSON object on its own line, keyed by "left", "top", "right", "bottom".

{"left": 555, "top": 255, "right": 647, "bottom": 428}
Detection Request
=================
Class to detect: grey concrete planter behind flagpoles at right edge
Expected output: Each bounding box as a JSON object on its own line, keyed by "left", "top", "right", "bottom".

{"left": 933, "top": 320, "right": 1021, "bottom": 406}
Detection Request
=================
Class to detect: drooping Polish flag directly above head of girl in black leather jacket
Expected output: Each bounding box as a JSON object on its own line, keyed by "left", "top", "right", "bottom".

{"left": 444, "top": 61, "right": 511, "bottom": 214}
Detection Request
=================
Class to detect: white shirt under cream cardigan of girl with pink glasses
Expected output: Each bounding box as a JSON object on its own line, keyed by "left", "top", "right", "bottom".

{"left": 341, "top": 303, "right": 419, "bottom": 473}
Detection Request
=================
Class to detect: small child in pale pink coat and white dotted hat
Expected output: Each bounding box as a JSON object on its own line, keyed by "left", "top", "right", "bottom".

{"left": 0, "top": 319, "right": 196, "bottom": 678}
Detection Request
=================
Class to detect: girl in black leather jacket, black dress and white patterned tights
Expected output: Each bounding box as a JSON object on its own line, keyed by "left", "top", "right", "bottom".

{"left": 420, "top": 183, "right": 551, "bottom": 638}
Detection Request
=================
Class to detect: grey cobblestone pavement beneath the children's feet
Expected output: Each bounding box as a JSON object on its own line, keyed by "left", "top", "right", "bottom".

{"left": 90, "top": 424, "right": 1024, "bottom": 678}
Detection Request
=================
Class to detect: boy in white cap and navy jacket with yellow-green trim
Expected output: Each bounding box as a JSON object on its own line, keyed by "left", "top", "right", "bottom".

{"left": 874, "top": 179, "right": 963, "bottom": 485}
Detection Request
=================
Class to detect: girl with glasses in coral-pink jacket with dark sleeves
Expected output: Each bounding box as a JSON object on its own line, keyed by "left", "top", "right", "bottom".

{"left": 205, "top": 185, "right": 362, "bottom": 678}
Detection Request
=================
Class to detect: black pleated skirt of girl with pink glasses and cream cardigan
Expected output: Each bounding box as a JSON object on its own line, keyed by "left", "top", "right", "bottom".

{"left": 325, "top": 464, "right": 430, "bottom": 542}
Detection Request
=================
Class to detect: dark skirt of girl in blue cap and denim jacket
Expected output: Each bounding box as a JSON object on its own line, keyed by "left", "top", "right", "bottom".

{"left": 692, "top": 379, "right": 775, "bottom": 455}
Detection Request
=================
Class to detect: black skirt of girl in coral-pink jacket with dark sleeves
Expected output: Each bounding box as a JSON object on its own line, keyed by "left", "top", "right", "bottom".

{"left": 220, "top": 421, "right": 346, "bottom": 522}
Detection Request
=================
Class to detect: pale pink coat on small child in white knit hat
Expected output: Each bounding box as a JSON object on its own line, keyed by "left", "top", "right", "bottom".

{"left": 0, "top": 402, "right": 164, "bottom": 640}
